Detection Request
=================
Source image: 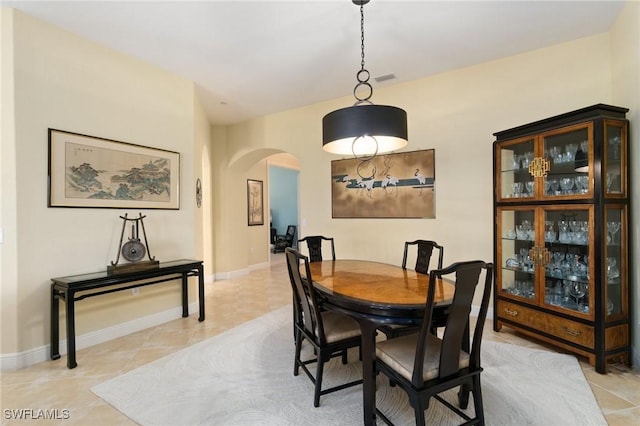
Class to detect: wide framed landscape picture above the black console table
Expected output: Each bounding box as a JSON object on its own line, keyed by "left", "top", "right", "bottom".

{"left": 48, "top": 129, "right": 180, "bottom": 210}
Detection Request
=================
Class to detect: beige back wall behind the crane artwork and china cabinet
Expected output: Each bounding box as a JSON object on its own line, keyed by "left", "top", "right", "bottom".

{"left": 216, "top": 2, "right": 640, "bottom": 364}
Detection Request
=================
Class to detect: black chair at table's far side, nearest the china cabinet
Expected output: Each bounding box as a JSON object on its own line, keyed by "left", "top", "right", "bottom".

{"left": 379, "top": 240, "right": 446, "bottom": 339}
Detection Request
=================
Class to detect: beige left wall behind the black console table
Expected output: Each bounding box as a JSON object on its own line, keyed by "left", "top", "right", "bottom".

{"left": 1, "top": 8, "right": 202, "bottom": 362}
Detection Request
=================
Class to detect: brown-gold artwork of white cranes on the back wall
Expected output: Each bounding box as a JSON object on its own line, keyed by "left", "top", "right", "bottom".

{"left": 331, "top": 149, "right": 436, "bottom": 219}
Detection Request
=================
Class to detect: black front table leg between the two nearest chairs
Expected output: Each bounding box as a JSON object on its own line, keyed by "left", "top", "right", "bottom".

{"left": 353, "top": 316, "right": 376, "bottom": 426}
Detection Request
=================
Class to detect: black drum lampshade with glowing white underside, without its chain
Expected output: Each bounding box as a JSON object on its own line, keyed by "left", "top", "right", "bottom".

{"left": 322, "top": 104, "right": 408, "bottom": 156}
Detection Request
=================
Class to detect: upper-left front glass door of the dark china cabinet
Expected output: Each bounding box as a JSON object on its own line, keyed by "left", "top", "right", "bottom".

{"left": 497, "top": 138, "right": 535, "bottom": 200}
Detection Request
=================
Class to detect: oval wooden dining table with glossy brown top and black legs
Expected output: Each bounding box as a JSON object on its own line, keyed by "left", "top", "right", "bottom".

{"left": 302, "top": 259, "right": 455, "bottom": 425}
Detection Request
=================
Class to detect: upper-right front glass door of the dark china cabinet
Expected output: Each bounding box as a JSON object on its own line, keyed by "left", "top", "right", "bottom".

{"left": 542, "top": 123, "right": 593, "bottom": 198}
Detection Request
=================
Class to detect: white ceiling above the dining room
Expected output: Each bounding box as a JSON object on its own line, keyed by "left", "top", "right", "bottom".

{"left": 1, "top": 0, "right": 624, "bottom": 124}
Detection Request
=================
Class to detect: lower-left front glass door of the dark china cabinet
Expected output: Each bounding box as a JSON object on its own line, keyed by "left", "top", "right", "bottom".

{"left": 498, "top": 208, "right": 537, "bottom": 300}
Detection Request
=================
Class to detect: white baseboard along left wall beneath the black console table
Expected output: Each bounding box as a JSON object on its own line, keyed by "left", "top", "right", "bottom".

{"left": 0, "top": 302, "right": 199, "bottom": 371}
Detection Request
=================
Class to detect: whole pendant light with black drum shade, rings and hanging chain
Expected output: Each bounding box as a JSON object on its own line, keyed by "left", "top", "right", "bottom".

{"left": 322, "top": 0, "right": 408, "bottom": 158}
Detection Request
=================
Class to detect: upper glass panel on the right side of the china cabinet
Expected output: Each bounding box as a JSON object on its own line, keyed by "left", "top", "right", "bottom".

{"left": 603, "top": 121, "right": 627, "bottom": 197}
